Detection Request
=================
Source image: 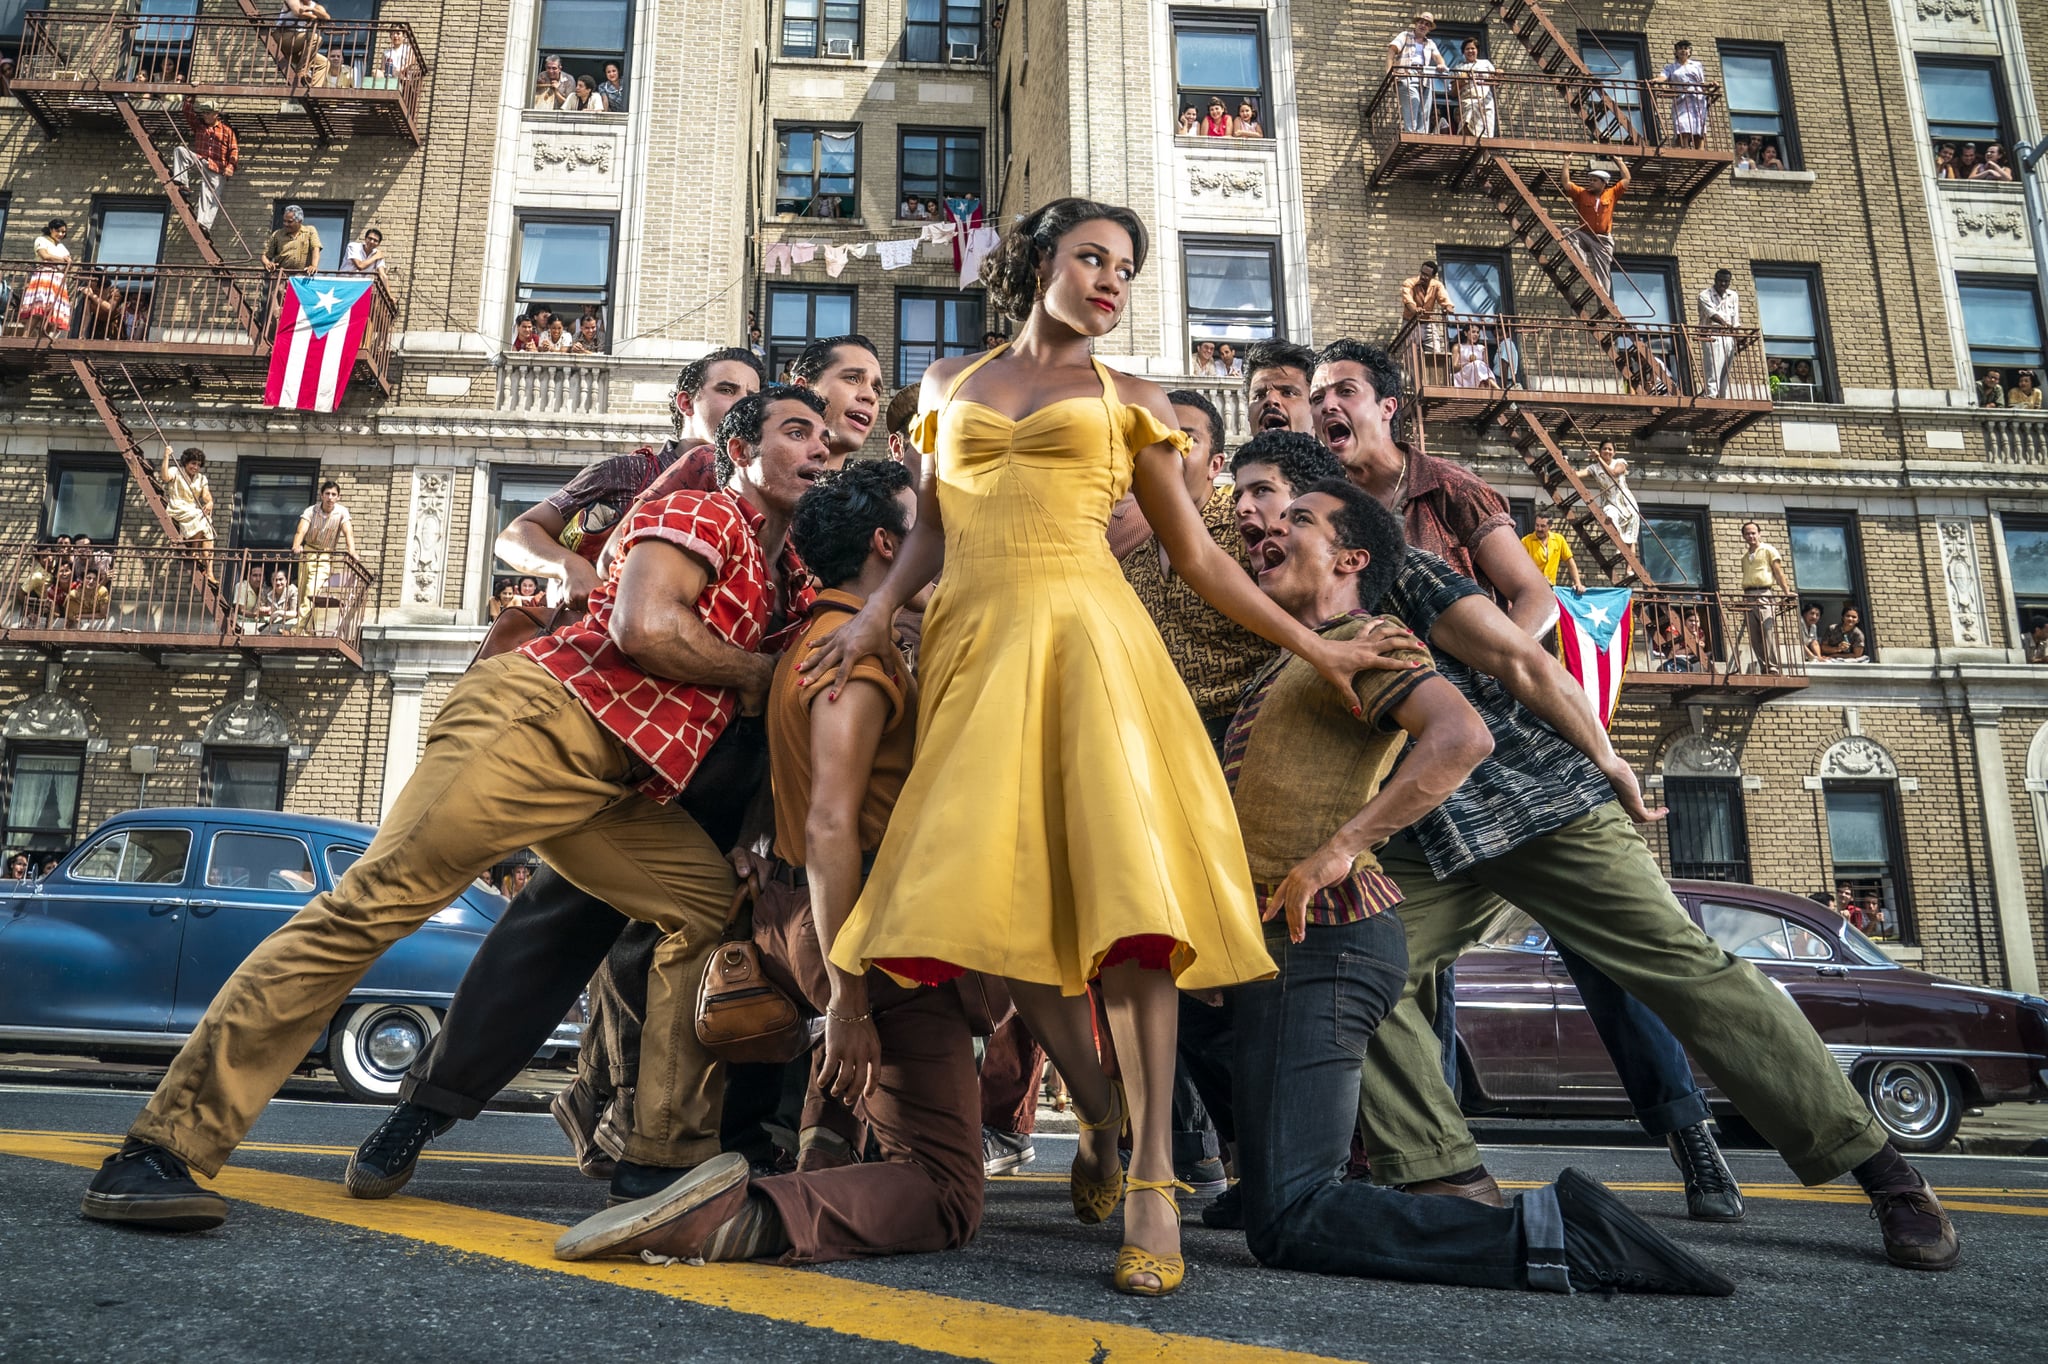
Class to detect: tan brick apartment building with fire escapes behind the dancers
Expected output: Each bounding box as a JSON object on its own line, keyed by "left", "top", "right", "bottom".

{"left": 0, "top": 0, "right": 2048, "bottom": 989}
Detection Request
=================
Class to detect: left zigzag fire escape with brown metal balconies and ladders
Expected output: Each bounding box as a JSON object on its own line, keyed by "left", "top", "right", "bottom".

{"left": 0, "top": 0, "right": 426, "bottom": 664}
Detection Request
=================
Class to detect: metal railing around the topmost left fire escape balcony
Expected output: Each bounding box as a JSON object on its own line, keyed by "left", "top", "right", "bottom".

{"left": 14, "top": 12, "right": 426, "bottom": 127}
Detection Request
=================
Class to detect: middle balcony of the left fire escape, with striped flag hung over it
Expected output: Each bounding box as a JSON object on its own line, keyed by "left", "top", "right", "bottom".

{"left": 0, "top": 260, "right": 397, "bottom": 393}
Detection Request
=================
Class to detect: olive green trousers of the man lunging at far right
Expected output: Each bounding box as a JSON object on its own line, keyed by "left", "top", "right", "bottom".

{"left": 1358, "top": 801, "right": 1884, "bottom": 1184}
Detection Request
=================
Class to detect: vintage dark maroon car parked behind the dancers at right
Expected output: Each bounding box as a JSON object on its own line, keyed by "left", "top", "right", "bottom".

{"left": 1456, "top": 881, "right": 2048, "bottom": 1151}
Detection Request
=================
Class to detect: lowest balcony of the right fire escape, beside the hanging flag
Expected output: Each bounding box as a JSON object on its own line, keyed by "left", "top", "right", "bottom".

{"left": 1622, "top": 588, "right": 1808, "bottom": 705}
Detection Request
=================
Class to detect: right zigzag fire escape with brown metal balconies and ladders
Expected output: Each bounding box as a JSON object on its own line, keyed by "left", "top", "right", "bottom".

{"left": 1366, "top": 0, "right": 1806, "bottom": 696}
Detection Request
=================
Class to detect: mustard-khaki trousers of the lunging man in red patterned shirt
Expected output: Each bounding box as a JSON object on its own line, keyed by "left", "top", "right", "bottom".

{"left": 129, "top": 653, "right": 733, "bottom": 1176}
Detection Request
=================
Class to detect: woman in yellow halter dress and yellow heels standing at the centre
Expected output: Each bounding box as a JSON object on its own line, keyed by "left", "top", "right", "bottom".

{"left": 805, "top": 199, "right": 1400, "bottom": 1294}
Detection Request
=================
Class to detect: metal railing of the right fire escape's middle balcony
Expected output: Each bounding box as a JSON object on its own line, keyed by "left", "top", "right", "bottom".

{"left": 1389, "top": 313, "right": 1772, "bottom": 403}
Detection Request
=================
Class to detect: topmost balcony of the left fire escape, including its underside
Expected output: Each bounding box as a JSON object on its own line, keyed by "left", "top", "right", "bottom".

{"left": 12, "top": 12, "right": 426, "bottom": 145}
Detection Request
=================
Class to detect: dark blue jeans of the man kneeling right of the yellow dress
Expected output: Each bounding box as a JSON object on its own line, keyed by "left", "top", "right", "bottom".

{"left": 1235, "top": 913, "right": 1563, "bottom": 1288}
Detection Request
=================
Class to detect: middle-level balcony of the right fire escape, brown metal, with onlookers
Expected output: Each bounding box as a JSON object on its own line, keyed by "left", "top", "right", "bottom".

{"left": 1389, "top": 313, "right": 1772, "bottom": 440}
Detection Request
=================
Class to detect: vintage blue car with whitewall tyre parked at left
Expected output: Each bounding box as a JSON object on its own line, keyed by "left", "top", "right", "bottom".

{"left": 0, "top": 809, "right": 580, "bottom": 1102}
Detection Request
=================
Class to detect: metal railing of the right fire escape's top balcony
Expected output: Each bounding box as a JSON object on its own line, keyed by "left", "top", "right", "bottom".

{"left": 1366, "top": 68, "right": 1735, "bottom": 156}
